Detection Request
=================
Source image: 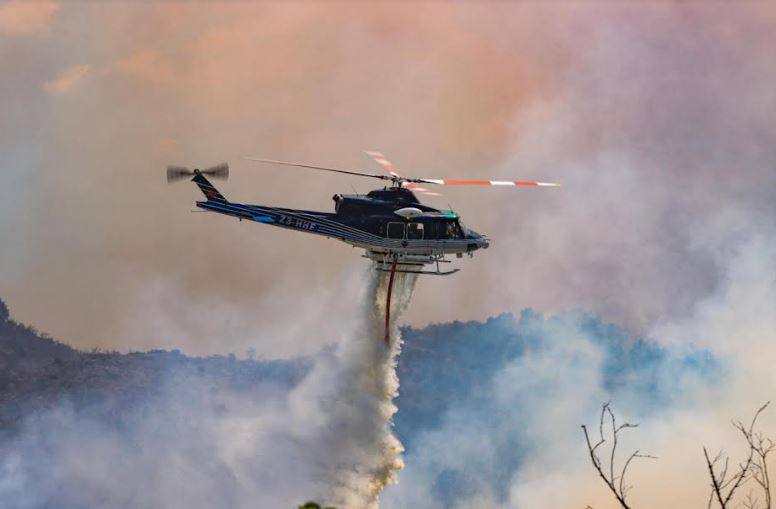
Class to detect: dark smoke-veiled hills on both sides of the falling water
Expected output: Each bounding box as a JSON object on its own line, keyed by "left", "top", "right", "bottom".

{"left": 0, "top": 300, "right": 716, "bottom": 444}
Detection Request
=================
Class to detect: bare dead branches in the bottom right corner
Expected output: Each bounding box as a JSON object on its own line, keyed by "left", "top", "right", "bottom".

{"left": 703, "top": 401, "right": 776, "bottom": 509}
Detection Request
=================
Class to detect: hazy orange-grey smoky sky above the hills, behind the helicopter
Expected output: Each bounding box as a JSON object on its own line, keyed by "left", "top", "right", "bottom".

{"left": 0, "top": 1, "right": 776, "bottom": 356}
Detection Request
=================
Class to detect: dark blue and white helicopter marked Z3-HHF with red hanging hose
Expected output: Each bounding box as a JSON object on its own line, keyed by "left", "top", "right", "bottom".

{"left": 167, "top": 151, "right": 559, "bottom": 342}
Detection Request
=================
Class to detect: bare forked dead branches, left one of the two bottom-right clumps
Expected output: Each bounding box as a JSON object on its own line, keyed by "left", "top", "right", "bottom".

{"left": 582, "top": 402, "right": 655, "bottom": 509}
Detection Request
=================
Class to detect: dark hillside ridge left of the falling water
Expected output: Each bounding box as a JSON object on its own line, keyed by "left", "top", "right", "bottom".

{"left": 0, "top": 300, "right": 310, "bottom": 433}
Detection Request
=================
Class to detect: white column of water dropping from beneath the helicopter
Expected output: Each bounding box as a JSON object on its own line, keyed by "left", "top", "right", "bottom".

{"left": 295, "top": 272, "right": 417, "bottom": 509}
